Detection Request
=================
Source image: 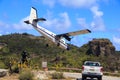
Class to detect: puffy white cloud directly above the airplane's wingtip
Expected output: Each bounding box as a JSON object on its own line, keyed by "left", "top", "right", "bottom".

{"left": 77, "top": 6, "right": 105, "bottom": 31}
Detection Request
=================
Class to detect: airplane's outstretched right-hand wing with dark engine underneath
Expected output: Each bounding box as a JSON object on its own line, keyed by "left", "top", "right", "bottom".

{"left": 56, "top": 29, "right": 91, "bottom": 41}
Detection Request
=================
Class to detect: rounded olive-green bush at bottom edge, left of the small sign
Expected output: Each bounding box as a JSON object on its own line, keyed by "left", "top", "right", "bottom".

{"left": 19, "top": 70, "right": 34, "bottom": 80}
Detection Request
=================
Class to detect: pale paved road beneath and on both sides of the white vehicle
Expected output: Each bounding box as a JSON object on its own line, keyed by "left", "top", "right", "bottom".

{"left": 64, "top": 72, "right": 120, "bottom": 80}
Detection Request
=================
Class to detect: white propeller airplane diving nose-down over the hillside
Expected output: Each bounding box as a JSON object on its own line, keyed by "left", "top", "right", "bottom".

{"left": 24, "top": 7, "right": 91, "bottom": 50}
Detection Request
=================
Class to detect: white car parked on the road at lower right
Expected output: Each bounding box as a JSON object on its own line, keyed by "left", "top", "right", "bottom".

{"left": 82, "top": 61, "right": 103, "bottom": 80}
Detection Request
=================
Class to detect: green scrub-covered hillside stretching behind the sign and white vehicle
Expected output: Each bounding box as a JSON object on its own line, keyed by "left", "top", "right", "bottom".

{"left": 0, "top": 33, "right": 120, "bottom": 71}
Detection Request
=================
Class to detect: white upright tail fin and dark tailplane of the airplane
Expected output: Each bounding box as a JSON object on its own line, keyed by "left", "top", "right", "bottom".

{"left": 24, "top": 7, "right": 46, "bottom": 24}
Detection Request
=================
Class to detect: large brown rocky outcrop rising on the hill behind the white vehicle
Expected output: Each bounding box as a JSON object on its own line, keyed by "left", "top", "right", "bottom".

{"left": 87, "top": 39, "right": 115, "bottom": 56}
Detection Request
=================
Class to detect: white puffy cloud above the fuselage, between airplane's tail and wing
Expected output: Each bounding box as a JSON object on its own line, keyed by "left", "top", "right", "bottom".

{"left": 43, "top": 12, "right": 71, "bottom": 31}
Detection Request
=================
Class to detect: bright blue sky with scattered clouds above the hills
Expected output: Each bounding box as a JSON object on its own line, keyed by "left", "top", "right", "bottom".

{"left": 0, "top": 0, "right": 120, "bottom": 51}
